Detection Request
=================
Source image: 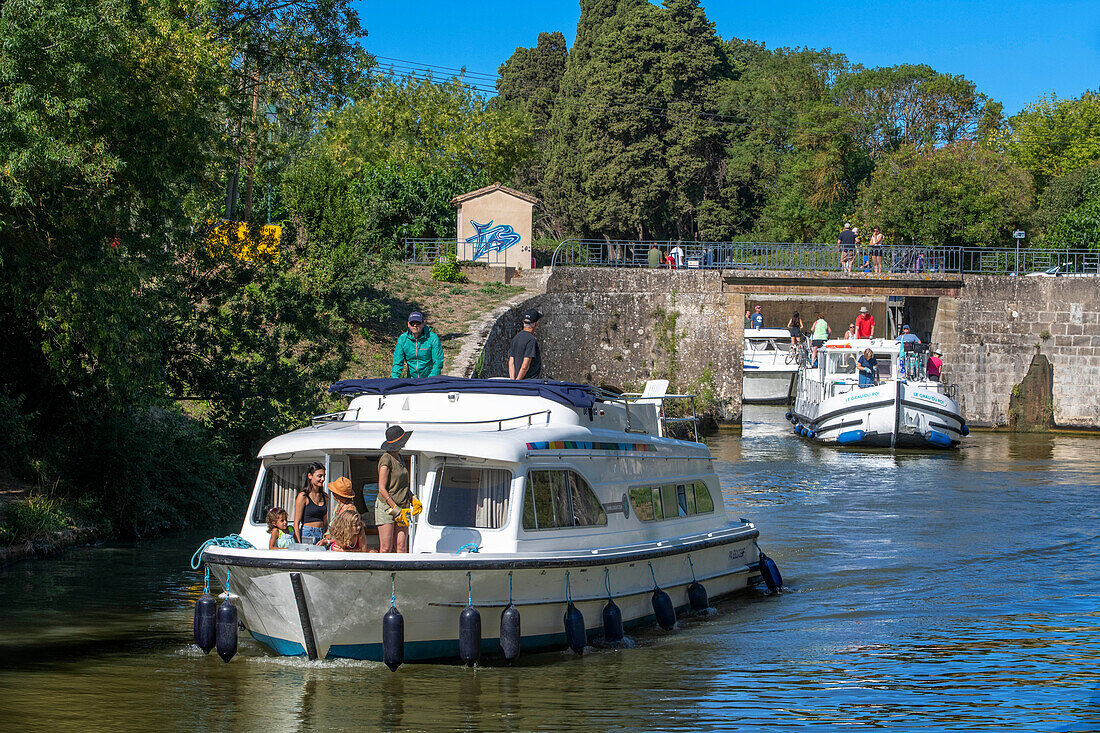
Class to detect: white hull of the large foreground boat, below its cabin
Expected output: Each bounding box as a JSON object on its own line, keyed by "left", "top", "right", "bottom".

{"left": 205, "top": 525, "right": 759, "bottom": 660}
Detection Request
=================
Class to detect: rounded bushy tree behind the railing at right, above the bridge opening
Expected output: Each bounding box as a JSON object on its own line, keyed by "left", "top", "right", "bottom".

{"left": 857, "top": 141, "right": 1033, "bottom": 247}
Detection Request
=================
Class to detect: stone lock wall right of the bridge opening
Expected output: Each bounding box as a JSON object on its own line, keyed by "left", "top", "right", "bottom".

{"left": 933, "top": 275, "right": 1100, "bottom": 428}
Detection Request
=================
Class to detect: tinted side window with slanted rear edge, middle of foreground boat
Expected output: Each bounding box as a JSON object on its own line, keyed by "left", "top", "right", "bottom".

{"left": 524, "top": 471, "right": 607, "bottom": 529}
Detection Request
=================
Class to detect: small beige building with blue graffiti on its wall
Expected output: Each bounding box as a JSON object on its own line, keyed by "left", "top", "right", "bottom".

{"left": 451, "top": 183, "right": 539, "bottom": 270}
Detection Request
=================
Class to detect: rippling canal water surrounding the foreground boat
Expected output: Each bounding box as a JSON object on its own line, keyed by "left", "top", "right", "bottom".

{"left": 0, "top": 408, "right": 1100, "bottom": 732}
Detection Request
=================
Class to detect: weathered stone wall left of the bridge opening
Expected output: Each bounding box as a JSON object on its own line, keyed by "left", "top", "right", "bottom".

{"left": 483, "top": 267, "right": 745, "bottom": 422}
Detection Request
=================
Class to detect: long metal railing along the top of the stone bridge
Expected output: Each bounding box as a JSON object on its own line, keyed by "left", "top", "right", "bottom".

{"left": 552, "top": 239, "right": 1100, "bottom": 276}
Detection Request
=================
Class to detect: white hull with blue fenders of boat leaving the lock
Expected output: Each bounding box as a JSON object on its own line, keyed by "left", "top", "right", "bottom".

{"left": 792, "top": 381, "right": 969, "bottom": 449}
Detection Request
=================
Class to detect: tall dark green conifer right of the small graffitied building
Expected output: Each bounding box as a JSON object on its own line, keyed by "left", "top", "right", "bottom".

{"left": 546, "top": 0, "right": 728, "bottom": 239}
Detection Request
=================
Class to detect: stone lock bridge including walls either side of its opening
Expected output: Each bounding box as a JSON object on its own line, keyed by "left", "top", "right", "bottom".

{"left": 483, "top": 266, "right": 1100, "bottom": 429}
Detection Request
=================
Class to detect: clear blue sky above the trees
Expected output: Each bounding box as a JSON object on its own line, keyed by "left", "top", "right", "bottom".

{"left": 355, "top": 0, "right": 1100, "bottom": 114}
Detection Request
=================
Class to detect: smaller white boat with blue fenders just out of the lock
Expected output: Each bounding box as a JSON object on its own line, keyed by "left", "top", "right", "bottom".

{"left": 788, "top": 339, "right": 970, "bottom": 448}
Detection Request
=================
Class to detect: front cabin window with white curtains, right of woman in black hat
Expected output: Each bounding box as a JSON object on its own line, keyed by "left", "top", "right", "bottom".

{"left": 428, "top": 466, "right": 512, "bottom": 529}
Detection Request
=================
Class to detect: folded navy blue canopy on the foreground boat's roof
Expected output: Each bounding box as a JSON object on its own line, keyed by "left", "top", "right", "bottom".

{"left": 329, "top": 376, "right": 596, "bottom": 408}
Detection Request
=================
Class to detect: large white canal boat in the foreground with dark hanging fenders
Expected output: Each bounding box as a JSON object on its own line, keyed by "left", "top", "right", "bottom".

{"left": 196, "top": 378, "right": 782, "bottom": 661}
